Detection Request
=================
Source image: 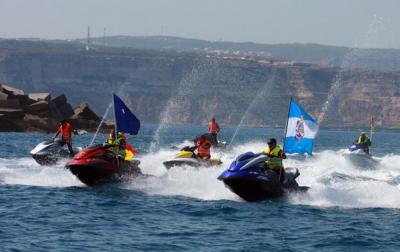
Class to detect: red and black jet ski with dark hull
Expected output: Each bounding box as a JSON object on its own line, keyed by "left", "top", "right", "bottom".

{"left": 66, "top": 144, "right": 142, "bottom": 186}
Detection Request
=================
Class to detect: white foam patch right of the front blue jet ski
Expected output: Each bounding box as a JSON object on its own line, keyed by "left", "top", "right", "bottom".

{"left": 288, "top": 151, "right": 400, "bottom": 208}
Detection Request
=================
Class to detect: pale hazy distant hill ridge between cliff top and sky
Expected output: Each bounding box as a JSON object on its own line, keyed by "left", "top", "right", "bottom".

{"left": 86, "top": 36, "right": 400, "bottom": 71}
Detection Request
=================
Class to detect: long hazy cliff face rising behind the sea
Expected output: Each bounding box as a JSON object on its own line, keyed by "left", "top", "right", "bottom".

{"left": 0, "top": 43, "right": 400, "bottom": 127}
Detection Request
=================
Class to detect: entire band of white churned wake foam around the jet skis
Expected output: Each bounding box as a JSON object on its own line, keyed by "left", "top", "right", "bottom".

{"left": 0, "top": 142, "right": 400, "bottom": 208}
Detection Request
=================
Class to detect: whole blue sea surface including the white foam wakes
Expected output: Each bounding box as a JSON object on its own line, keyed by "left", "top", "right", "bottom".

{"left": 0, "top": 125, "right": 400, "bottom": 251}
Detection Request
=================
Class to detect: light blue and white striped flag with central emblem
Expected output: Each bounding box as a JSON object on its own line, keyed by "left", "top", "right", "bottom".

{"left": 284, "top": 99, "right": 319, "bottom": 155}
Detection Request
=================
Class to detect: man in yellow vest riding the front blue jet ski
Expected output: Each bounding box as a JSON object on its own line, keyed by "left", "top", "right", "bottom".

{"left": 263, "top": 138, "right": 286, "bottom": 182}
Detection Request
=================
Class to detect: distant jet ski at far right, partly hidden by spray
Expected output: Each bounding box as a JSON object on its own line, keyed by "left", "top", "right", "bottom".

{"left": 343, "top": 143, "right": 378, "bottom": 168}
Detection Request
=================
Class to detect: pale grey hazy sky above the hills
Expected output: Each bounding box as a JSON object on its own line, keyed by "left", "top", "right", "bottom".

{"left": 0, "top": 0, "right": 400, "bottom": 48}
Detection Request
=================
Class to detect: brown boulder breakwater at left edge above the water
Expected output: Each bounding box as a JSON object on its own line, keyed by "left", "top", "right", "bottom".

{"left": 0, "top": 84, "right": 113, "bottom": 132}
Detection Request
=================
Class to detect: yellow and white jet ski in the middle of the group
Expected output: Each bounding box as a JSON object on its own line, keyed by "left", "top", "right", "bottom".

{"left": 163, "top": 146, "right": 222, "bottom": 170}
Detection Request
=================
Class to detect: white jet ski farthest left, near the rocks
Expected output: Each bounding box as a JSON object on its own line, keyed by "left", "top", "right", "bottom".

{"left": 30, "top": 139, "right": 82, "bottom": 165}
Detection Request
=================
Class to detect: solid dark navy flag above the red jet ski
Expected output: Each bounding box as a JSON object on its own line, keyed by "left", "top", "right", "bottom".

{"left": 113, "top": 94, "right": 140, "bottom": 135}
